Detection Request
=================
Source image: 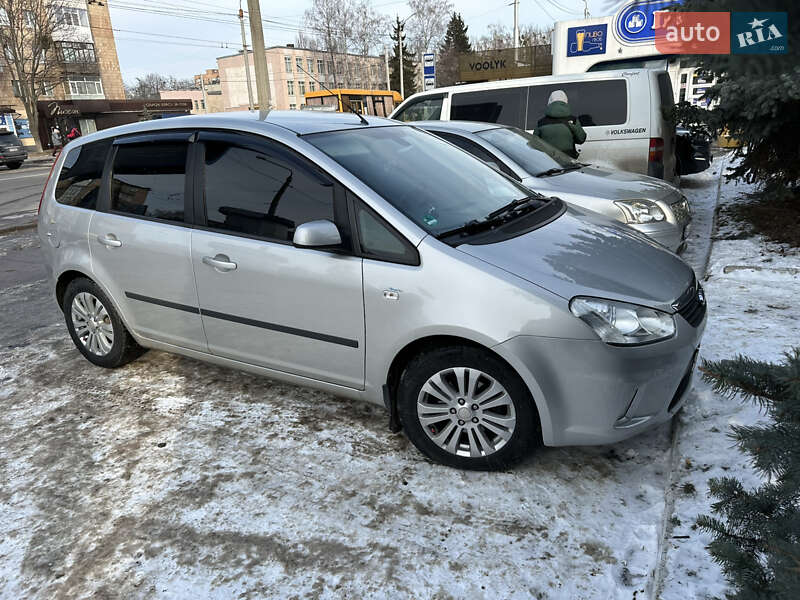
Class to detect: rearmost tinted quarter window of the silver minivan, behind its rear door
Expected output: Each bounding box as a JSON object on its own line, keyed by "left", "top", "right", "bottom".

{"left": 55, "top": 139, "right": 111, "bottom": 209}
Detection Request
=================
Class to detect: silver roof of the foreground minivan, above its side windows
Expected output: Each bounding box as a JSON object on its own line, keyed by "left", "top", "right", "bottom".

{"left": 79, "top": 110, "right": 402, "bottom": 139}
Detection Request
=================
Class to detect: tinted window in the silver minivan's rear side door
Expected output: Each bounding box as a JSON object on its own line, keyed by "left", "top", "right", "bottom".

{"left": 111, "top": 142, "right": 188, "bottom": 222}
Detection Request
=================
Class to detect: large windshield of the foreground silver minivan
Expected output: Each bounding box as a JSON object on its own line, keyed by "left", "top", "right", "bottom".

{"left": 305, "top": 125, "right": 532, "bottom": 235}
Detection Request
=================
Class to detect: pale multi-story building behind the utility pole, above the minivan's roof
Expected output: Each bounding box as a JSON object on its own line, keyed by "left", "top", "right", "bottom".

{"left": 217, "top": 44, "right": 387, "bottom": 111}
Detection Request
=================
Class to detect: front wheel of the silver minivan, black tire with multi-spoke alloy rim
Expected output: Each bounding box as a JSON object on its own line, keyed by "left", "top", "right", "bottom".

{"left": 397, "top": 346, "right": 541, "bottom": 471}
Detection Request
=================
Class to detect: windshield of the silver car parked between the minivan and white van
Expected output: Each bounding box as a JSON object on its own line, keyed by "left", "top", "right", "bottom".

{"left": 475, "top": 127, "right": 578, "bottom": 175}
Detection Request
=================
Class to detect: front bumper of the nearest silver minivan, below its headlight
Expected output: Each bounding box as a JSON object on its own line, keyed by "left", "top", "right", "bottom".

{"left": 501, "top": 314, "right": 705, "bottom": 446}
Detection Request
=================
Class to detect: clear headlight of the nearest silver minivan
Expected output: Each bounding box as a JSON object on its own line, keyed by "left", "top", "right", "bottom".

{"left": 569, "top": 296, "right": 675, "bottom": 345}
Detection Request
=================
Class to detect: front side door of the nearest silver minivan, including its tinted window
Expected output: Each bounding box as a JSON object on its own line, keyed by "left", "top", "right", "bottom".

{"left": 192, "top": 131, "right": 364, "bottom": 388}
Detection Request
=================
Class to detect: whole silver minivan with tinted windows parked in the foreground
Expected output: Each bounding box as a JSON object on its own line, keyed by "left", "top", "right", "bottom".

{"left": 38, "top": 111, "right": 706, "bottom": 469}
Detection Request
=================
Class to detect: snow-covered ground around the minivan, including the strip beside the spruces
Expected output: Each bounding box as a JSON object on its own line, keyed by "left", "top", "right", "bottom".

{"left": 0, "top": 161, "right": 798, "bottom": 600}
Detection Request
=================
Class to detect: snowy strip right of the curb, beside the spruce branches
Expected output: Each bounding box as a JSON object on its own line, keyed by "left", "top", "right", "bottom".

{"left": 657, "top": 163, "right": 800, "bottom": 600}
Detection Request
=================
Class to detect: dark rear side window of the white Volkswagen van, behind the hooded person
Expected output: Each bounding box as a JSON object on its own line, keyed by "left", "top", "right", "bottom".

{"left": 526, "top": 79, "right": 628, "bottom": 129}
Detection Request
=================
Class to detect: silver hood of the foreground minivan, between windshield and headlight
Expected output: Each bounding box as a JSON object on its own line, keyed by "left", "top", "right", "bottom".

{"left": 458, "top": 207, "right": 694, "bottom": 313}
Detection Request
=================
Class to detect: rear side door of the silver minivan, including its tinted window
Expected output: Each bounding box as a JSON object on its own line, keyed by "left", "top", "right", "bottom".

{"left": 89, "top": 132, "right": 207, "bottom": 351}
